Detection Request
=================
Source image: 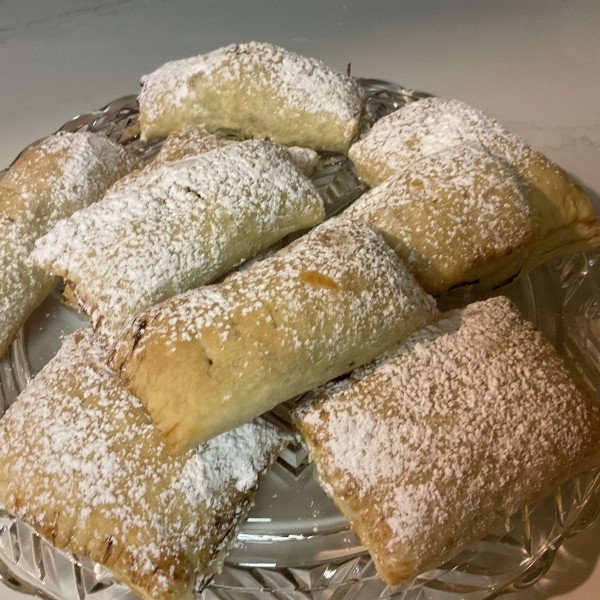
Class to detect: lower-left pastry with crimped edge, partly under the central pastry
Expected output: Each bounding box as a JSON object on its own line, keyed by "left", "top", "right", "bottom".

{"left": 0, "top": 330, "right": 286, "bottom": 600}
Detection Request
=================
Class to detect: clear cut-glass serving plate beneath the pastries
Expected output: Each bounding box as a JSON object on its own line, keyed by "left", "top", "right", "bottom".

{"left": 0, "top": 79, "right": 600, "bottom": 600}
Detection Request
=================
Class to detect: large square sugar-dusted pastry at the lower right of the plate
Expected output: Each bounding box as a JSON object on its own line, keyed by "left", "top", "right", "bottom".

{"left": 296, "top": 297, "right": 600, "bottom": 585}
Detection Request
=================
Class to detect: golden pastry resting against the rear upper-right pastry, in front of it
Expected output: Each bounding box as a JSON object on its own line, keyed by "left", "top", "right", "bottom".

{"left": 345, "top": 145, "right": 543, "bottom": 294}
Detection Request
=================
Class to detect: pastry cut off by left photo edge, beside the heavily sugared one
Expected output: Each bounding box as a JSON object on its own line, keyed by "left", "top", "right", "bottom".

{"left": 0, "top": 132, "right": 137, "bottom": 356}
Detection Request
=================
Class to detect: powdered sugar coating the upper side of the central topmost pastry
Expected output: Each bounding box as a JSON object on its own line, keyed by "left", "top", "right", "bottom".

{"left": 117, "top": 219, "right": 436, "bottom": 369}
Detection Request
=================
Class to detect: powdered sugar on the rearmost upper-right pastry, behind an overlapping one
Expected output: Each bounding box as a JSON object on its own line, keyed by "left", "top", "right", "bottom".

{"left": 348, "top": 98, "right": 532, "bottom": 186}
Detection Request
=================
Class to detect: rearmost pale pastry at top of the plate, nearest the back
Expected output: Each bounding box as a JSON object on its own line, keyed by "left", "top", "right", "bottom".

{"left": 139, "top": 42, "right": 364, "bottom": 152}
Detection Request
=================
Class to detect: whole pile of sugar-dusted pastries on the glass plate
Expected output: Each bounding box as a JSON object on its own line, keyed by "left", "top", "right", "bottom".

{"left": 0, "top": 43, "right": 600, "bottom": 600}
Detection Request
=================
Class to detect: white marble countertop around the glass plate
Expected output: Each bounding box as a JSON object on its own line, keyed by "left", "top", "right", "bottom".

{"left": 0, "top": 0, "right": 600, "bottom": 600}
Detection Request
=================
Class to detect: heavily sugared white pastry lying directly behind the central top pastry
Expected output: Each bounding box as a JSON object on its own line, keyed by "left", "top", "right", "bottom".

{"left": 32, "top": 141, "right": 324, "bottom": 340}
